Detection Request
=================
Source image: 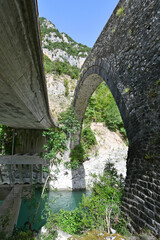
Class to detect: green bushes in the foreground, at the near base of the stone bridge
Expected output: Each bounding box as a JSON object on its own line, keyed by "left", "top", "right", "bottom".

{"left": 43, "top": 164, "right": 126, "bottom": 234}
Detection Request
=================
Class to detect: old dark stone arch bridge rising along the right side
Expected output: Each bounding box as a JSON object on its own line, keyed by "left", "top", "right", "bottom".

{"left": 74, "top": 0, "right": 160, "bottom": 236}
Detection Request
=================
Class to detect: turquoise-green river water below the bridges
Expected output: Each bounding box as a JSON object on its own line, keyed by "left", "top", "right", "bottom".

{"left": 17, "top": 189, "right": 89, "bottom": 230}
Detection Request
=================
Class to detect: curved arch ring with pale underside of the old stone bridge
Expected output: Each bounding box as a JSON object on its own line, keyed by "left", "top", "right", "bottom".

{"left": 73, "top": 60, "right": 132, "bottom": 146}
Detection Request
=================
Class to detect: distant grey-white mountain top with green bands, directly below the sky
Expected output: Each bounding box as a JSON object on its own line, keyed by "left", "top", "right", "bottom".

{"left": 39, "top": 17, "right": 90, "bottom": 68}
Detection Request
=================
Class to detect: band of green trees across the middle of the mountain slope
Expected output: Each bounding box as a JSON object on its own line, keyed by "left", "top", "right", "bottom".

{"left": 44, "top": 55, "right": 79, "bottom": 79}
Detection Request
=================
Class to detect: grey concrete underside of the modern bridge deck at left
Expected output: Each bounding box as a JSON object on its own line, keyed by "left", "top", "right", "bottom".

{"left": 0, "top": 0, "right": 54, "bottom": 129}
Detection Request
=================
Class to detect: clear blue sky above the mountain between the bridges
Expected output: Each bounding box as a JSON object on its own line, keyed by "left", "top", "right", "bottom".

{"left": 38, "top": 0, "right": 118, "bottom": 47}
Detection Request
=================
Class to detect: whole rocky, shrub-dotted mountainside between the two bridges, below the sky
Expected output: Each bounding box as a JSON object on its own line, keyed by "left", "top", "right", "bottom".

{"left": 39, "top": 17, "right": 90, "bottom": 121}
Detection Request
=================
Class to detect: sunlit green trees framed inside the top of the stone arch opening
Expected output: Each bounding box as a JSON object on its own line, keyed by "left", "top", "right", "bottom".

{"left": 84, "top": 82, "right": 126, "bottom": 139}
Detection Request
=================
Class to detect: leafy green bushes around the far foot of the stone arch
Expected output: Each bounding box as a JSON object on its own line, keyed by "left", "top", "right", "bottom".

{"left": 43, "top": 108, "right": 97, "bottom": 171}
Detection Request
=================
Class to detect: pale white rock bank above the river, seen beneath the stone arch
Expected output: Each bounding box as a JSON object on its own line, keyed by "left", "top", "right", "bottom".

{"left": 50, "top": 123, "right": 128, "bottom": 190}
